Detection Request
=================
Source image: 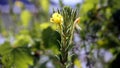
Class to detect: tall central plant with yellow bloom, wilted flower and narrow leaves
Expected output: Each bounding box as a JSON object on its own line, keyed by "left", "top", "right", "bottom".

{"left": 50, "top": 6, "right": 80, "bottom": 68}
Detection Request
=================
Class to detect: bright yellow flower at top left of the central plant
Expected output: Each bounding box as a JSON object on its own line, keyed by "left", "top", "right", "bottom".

{"left": 50, "top": 12, "right": 63, "bottom": 24}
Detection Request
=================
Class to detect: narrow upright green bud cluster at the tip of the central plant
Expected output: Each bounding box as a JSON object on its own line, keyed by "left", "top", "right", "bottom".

{"left": 61, "top": 6, "right": 77, "bottom": 26}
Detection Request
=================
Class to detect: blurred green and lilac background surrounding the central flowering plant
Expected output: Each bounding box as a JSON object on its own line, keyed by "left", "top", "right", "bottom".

{"left": 0, "top": 0, "right": 120, "bottom": 68}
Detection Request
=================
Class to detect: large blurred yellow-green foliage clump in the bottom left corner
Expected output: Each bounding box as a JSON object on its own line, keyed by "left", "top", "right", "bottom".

{"left": 0, "top": 42, "right": 33, "bottom": 68}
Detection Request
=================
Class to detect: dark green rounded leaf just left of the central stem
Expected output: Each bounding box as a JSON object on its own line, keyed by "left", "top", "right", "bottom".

{"left": 42, "top": 27, "right": 60, "bottom": 48}
